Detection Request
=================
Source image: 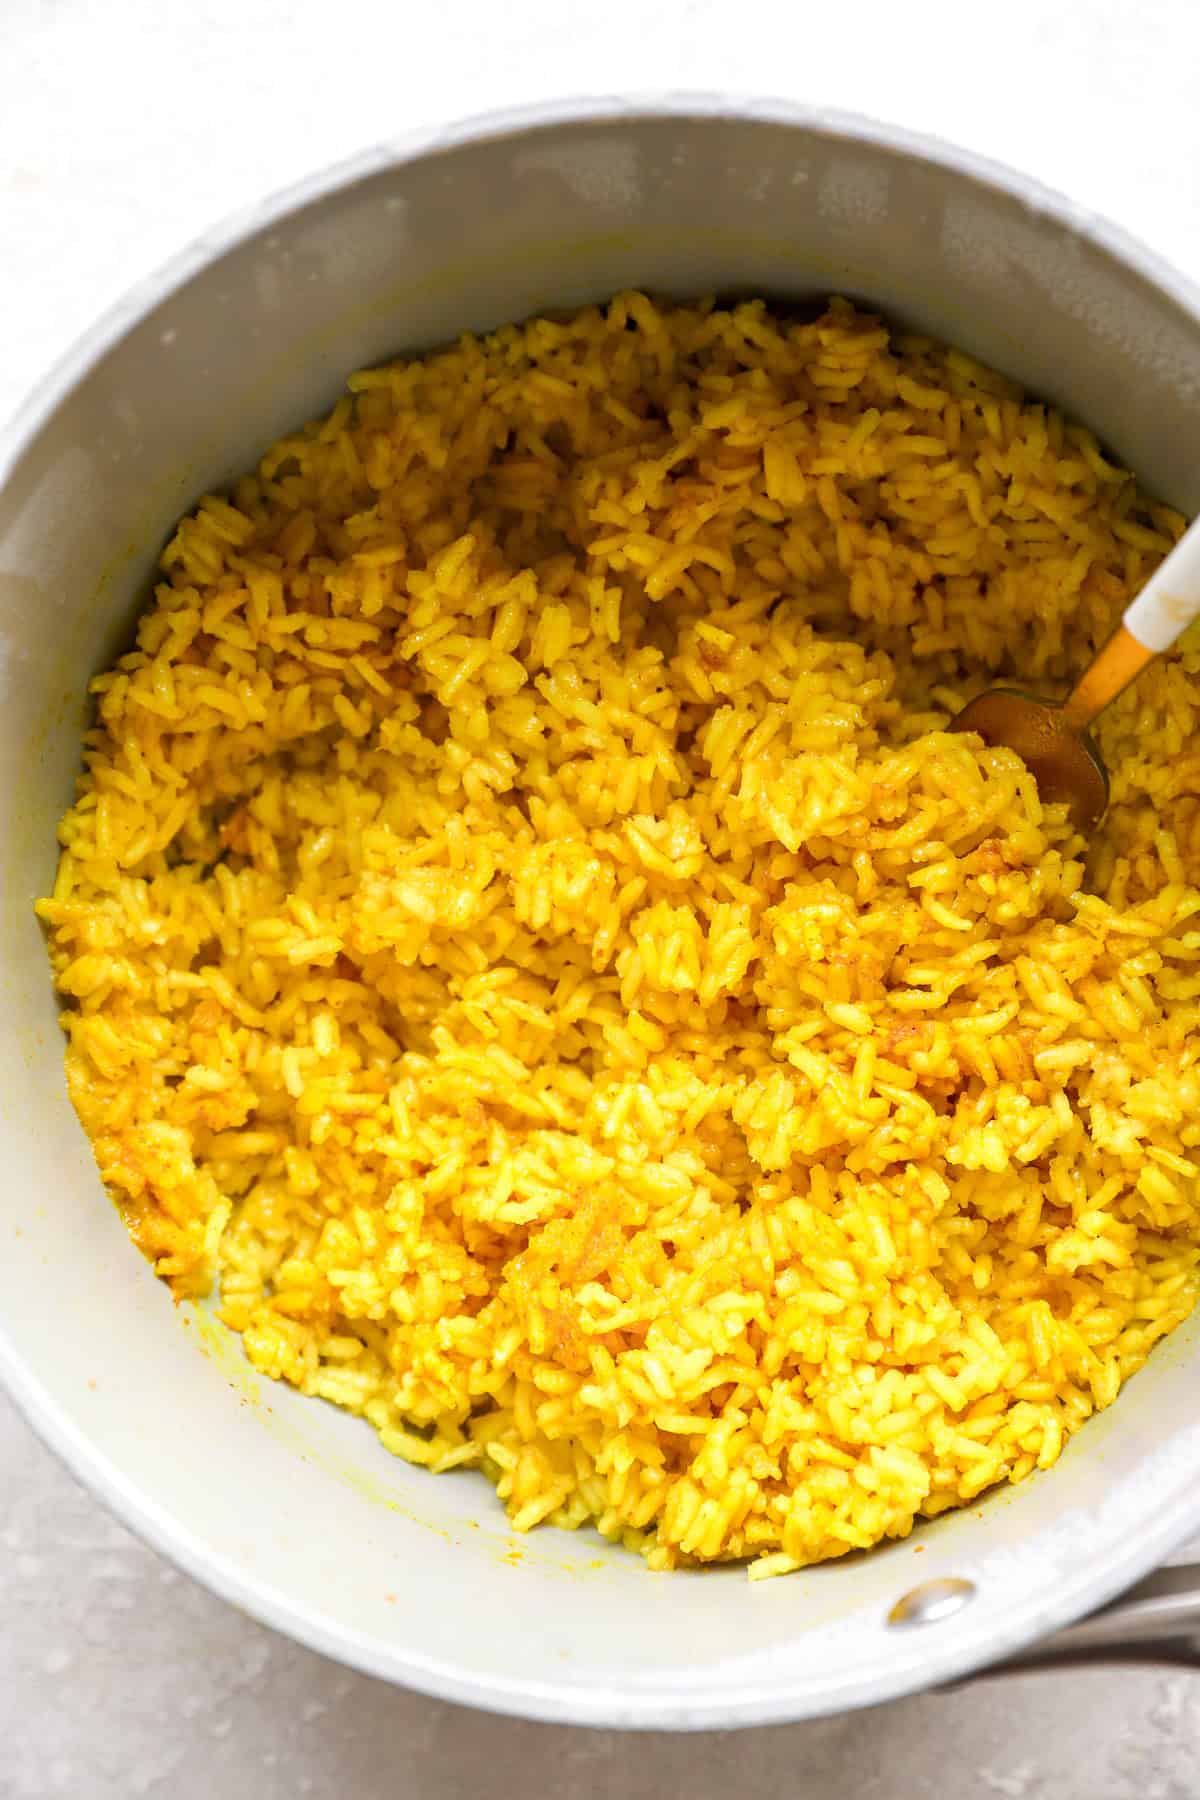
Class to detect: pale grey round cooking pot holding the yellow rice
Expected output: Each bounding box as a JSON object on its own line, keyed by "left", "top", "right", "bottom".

{"left": 0, "top": 97, "right": 1200, "bottom": 1726}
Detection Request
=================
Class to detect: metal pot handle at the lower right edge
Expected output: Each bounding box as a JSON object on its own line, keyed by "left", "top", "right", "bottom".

{"left": 981, "top": 1562, "right": 1200, "bottom": 1678}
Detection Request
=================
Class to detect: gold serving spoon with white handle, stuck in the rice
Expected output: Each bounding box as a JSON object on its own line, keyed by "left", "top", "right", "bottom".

{"left": 950, "top": 520, "right": 1200, "bottom": 832}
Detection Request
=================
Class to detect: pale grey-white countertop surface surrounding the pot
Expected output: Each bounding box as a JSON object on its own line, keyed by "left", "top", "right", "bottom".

{"left": 0, "top": 0, "right": 1200, "bottom": 1800}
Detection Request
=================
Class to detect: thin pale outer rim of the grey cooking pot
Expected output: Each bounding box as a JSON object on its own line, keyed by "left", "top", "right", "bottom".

{"left": 0, "top": 90, "right": 1200, "bottom": 1730}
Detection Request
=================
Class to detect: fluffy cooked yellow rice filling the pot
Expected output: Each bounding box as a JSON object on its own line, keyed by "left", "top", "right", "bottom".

{"left": 41, "top": 293, "right": 1200, "bottom": 1573}
